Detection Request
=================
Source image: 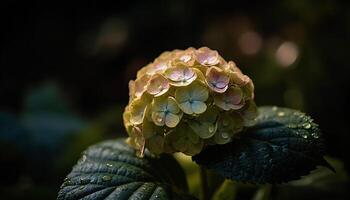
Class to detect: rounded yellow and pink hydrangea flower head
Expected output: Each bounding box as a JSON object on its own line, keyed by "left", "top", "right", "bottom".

{"left": 123, "top": 47, "right": 257, "bottom": 156}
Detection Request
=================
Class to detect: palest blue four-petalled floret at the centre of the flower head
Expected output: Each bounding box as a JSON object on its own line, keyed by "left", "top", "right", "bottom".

{"left": 175, "top": 82, "right": 209, "bottom": 115}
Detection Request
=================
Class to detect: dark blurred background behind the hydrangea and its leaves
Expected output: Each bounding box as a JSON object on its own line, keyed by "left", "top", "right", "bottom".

{"left": 0, "top": 0, "right": 350, "bottom": 199}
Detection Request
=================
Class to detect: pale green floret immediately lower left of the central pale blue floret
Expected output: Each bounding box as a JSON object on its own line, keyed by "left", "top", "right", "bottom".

{"left": 152, "top": 97, "right": 182, "bottom": 128}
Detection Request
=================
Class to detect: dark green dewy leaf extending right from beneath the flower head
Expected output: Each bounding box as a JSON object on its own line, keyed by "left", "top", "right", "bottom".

{"left": 192, "top": 107, "right": 333, "bottom": 183}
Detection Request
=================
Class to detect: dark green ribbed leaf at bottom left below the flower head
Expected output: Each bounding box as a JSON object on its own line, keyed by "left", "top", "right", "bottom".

{"left": 58, "top": 139, "right": 193, "bottom": 200}
